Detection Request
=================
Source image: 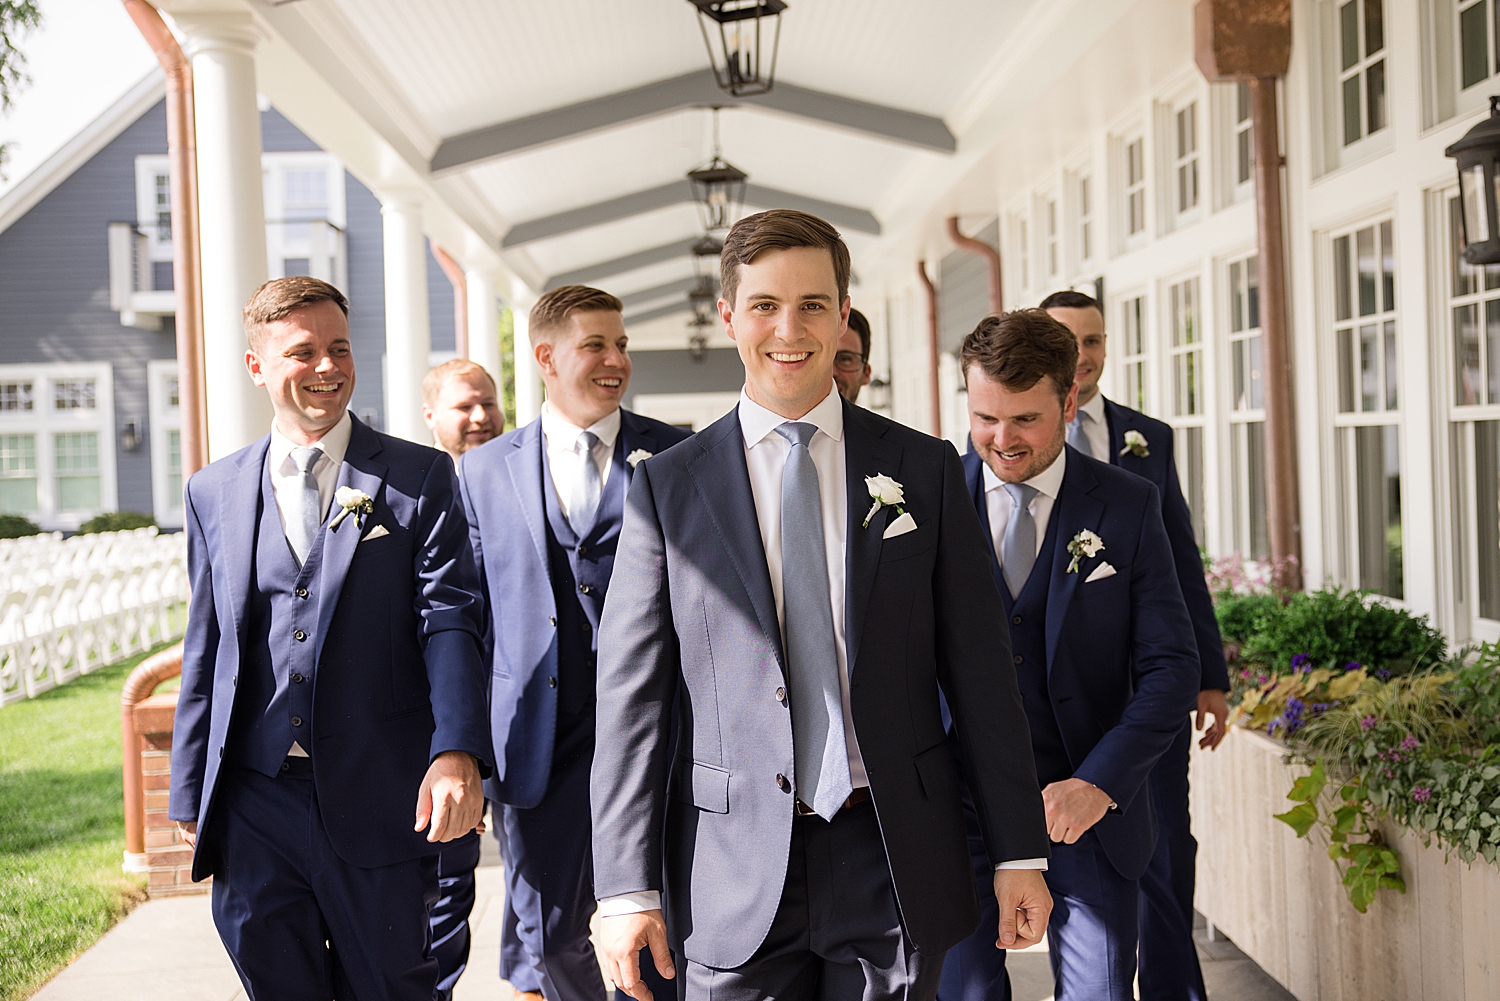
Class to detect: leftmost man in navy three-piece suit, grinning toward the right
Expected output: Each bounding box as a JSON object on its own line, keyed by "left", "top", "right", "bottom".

{"left": 170, "top": 278, "right": 491, "bottom": 1001}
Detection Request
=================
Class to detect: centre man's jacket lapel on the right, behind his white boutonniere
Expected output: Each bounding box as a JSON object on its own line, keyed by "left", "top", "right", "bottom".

{"left": 843, "top": 401, "right": 917, "bottom": 675}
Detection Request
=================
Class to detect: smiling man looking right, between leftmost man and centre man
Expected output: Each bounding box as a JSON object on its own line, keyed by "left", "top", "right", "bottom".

{"left": 459, "top": 285, "right": 690, "bottom": 1001}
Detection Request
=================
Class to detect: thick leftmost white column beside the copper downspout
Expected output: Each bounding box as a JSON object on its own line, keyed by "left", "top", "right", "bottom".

{"left": 177, "top": 14, "right": 272, "bottom": 461}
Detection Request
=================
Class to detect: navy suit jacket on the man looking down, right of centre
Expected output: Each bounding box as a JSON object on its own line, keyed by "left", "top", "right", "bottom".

{"left": 963, "top": 446, "right": 1199, "bottom": 879}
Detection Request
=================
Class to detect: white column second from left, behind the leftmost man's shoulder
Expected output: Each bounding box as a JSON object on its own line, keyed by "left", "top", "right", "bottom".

{"left": 380, "top": 195, "right": 432, "bottom": 444}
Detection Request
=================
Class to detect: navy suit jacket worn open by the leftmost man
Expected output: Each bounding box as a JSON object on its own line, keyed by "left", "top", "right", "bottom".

{"left": 170, "top": 419, "right": 492, "bottom": 879}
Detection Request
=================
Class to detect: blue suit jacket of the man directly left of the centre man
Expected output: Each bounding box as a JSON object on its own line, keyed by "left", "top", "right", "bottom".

{"left": 459, "top": 408, "right": 692, "bottom": 809}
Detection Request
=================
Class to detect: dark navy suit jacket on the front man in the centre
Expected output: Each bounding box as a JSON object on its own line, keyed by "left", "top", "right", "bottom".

{"left": 591, "top": 401, "right": 1049, "bottom": 969}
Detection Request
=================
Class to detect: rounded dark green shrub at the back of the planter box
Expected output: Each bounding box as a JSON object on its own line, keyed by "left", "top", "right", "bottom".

{"left": 1241, "top": 588, "right": 1448, "bottom": 677}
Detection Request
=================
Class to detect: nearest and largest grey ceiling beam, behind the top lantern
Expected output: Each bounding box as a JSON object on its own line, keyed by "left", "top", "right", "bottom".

{"left": 429, "top": 69, "right": 959, "bottom": 174}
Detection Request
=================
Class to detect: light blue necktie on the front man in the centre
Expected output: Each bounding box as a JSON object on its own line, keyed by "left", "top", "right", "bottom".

{"left": 776, "top": 422, "right": 854, "bottom": 821}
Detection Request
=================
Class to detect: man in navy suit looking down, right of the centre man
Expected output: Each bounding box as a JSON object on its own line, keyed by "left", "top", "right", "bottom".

{"left": 939, "top": 309, "right": 1199, "bottom": 1001}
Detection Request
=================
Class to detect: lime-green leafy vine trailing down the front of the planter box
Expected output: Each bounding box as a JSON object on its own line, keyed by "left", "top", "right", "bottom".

{"left": 1275, "top": 758, "right": 1406, "bottom": 914}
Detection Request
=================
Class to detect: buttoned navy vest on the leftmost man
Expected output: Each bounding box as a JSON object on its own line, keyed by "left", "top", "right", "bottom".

{"left": 227, "top": 459, "right": 327, "bottom": 776}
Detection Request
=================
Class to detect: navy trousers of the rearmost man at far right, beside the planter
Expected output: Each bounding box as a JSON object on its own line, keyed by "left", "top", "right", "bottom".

{"left": 1140, "top": 723, "right": 1208, "bottom": 1001}
